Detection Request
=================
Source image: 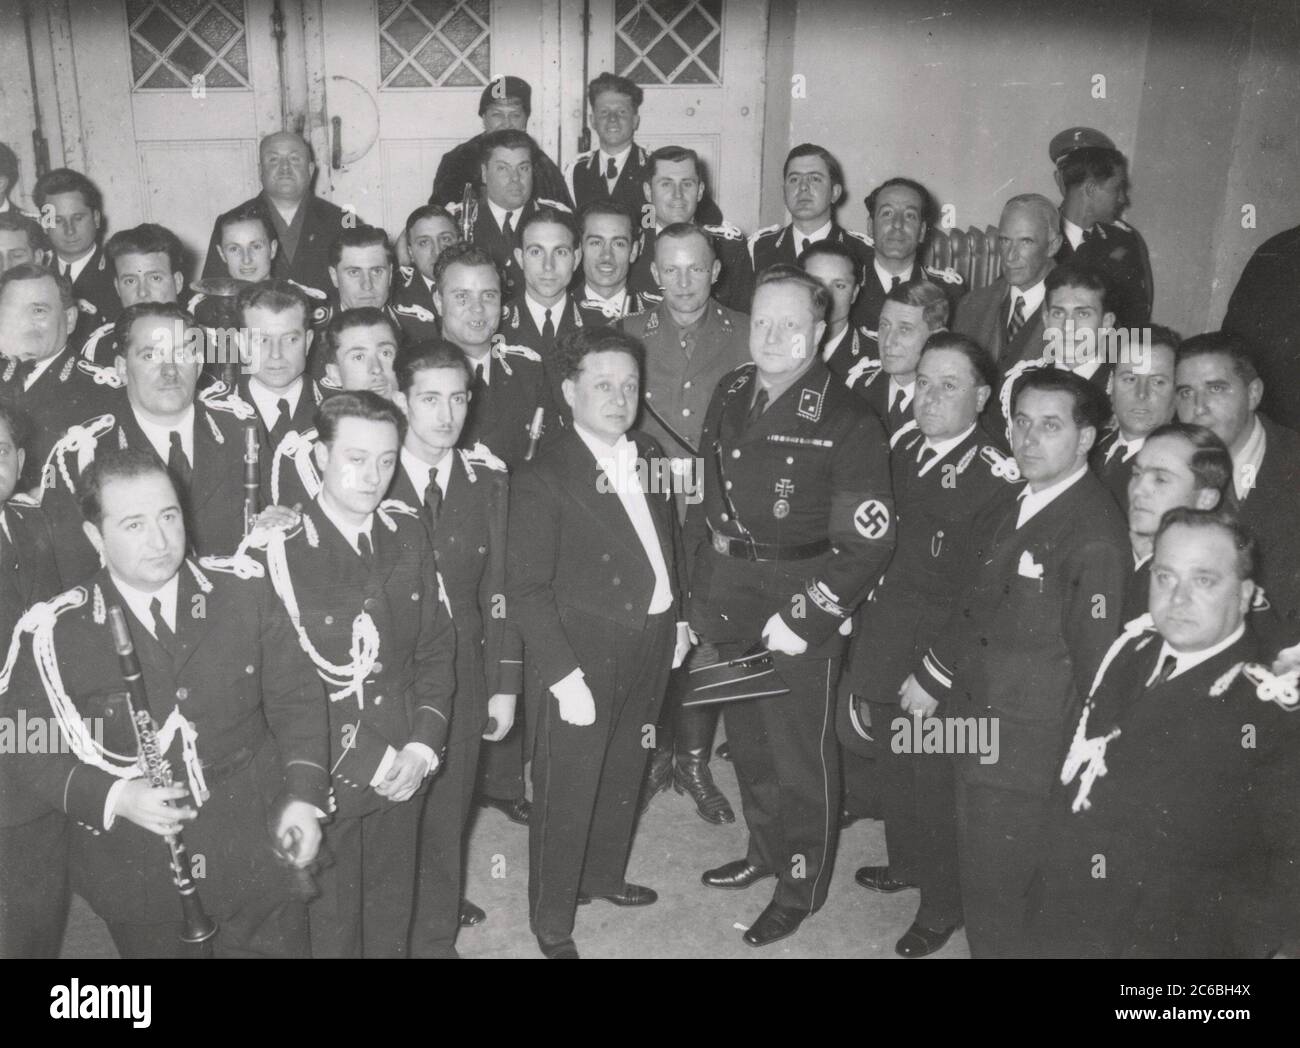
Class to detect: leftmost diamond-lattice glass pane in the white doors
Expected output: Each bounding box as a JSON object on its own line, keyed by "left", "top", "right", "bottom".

{"left": 126, "top": 0, "right": 250, "bottom": 91}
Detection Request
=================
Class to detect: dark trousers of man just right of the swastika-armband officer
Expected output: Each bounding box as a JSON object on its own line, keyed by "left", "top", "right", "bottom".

{"left": 871, "top": 703, "right": 962, "bottom": 928}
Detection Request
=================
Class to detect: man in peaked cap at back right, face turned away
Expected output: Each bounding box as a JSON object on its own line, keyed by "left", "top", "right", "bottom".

{"left": 1048, "top": 127, "right": 1154, "bottom": 328}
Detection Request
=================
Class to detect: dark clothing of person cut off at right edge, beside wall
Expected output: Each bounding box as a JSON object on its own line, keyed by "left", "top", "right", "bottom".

{"left": 1223, "top": 226, "right": 1300, "bottom": 429}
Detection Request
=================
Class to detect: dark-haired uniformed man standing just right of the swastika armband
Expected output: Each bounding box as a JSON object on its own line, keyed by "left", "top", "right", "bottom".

{"left": 836, "top": 335, "right": 1015, "bottom": 957}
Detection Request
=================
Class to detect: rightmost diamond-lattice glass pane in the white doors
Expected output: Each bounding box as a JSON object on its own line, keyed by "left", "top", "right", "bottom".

{"left": 614, "top": 0, "right": 723, "bottom": 85}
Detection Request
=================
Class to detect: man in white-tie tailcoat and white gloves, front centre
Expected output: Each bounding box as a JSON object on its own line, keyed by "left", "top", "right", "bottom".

{"left": 507, "top": 328, "right": 690, "bottom": 958}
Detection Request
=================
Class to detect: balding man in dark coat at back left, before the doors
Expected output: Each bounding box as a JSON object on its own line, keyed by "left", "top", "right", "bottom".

{"left": 203, "top": 131, "right": 353, "bottom": 290}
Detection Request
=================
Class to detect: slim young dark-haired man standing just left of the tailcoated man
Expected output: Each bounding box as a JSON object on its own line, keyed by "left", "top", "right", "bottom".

{"left": 389, "top": 342, "right": 524, "bottom": 957}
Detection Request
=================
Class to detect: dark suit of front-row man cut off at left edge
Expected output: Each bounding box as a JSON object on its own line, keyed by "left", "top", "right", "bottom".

{"left": 0, "top": 498, "right": 69, "bottom": 958}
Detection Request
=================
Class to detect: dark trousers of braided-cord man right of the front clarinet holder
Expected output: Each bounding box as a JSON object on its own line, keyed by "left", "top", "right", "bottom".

{"left": 308, "top": 794, "right": 424, "bottom": 957}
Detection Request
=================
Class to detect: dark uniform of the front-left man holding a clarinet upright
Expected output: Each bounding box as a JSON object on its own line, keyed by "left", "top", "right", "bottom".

{"left": 10, "top": 562, "right": 329, "bottom": 957}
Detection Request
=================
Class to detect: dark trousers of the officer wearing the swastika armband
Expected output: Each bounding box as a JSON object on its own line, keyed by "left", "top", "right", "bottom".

{"left": 719, "top": 644, "right": 840, "bottom": 913}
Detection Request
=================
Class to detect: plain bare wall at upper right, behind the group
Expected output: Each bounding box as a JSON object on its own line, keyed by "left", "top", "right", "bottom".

{"left": 762, "top": 0, "right": 1300, "bottom": 333}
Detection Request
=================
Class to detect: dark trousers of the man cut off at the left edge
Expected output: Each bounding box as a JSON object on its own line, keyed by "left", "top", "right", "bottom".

{"left": 0, "top": 811, "right": 70, "bottom": 960}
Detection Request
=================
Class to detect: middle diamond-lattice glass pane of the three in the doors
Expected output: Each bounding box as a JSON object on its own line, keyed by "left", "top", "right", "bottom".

{"left": 378, "top": 0, "right": 491, "bottom": 91}
